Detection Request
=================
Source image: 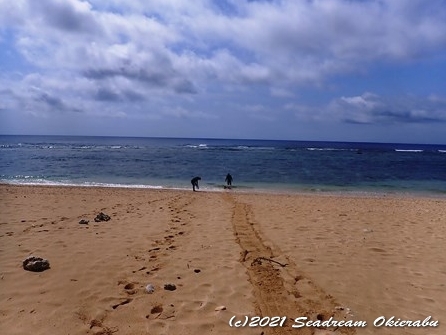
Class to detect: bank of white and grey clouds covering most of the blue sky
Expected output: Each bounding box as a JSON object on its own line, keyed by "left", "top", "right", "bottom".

{"left": 0, "top": 0, "right": 446, "bottom": 142}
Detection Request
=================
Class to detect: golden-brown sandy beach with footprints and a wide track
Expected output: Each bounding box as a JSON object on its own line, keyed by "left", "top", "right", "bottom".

{"left": 0, "top": 185, "right": 446, "bottom": 335}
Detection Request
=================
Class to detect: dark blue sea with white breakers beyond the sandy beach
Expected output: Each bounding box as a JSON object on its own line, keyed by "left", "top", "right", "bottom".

{"left": 0, "top": 136, "right": 446, "bottom": 196}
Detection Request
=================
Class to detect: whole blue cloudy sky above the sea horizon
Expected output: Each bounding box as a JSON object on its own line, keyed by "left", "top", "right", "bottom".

{"left": 0, "top": 0, "right": 446, "bottom": 144}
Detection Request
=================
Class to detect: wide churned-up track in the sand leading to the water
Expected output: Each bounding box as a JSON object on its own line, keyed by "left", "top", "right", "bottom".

{"left": 224, "top": 194, "right": 356, "bottom": 335}
